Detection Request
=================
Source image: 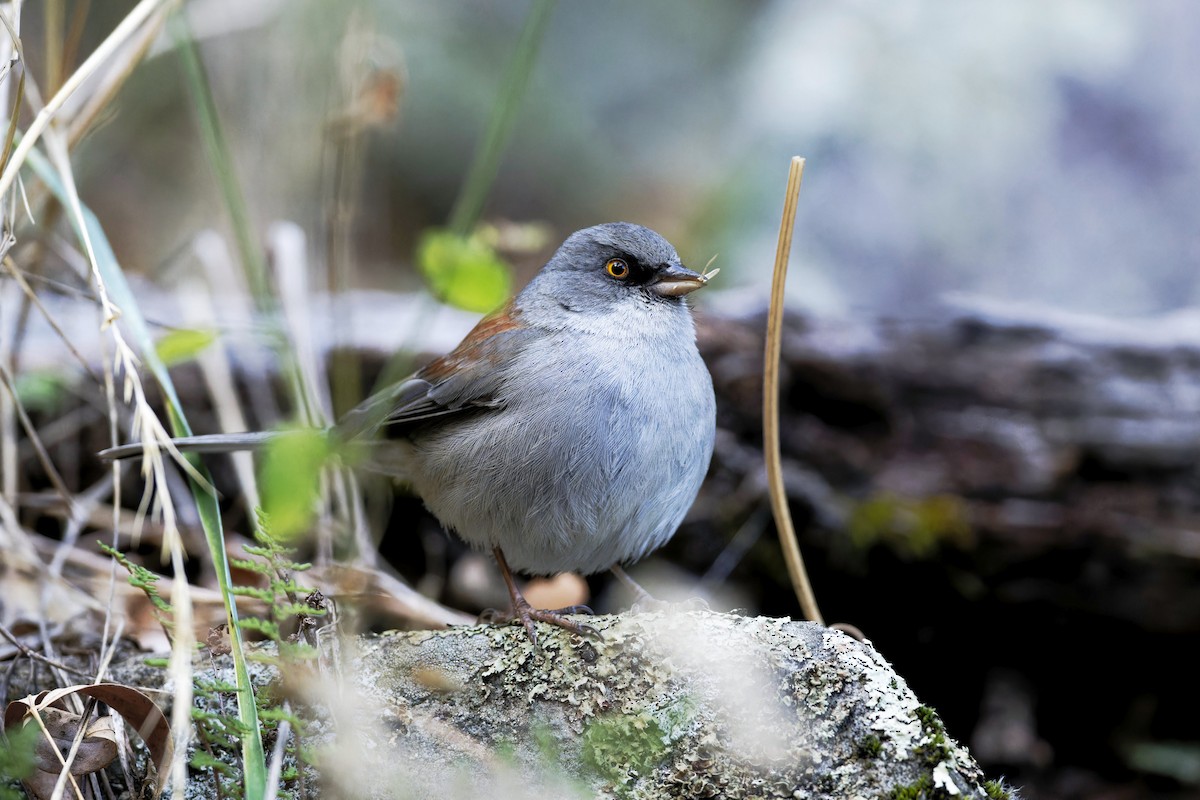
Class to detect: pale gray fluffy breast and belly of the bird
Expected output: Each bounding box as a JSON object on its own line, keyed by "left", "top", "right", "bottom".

{"left": 413, "top": 326, "right": 715, "bottom": 575}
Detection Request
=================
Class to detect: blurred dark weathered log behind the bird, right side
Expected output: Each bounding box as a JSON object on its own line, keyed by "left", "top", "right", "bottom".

{"left": 702, "top": 301, "right": 1200, "bottom": 632}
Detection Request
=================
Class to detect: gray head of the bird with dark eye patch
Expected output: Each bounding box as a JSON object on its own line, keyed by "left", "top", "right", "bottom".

{"left": 518, "top": 222, "right": 704, "bottom": 312}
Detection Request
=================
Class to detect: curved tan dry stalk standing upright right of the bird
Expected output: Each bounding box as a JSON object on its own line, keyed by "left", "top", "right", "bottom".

{"left": 762, "top": 156, "right": 824, "bottom": 625}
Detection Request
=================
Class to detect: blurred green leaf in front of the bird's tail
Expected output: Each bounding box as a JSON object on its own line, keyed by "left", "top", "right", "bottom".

{"left": 259, "top": 428, "right": 330, "bottom": 540}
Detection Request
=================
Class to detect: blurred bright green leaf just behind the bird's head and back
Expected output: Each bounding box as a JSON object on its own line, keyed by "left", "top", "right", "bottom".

{"left": 416, "top": 229, "right": 512, "bottom": 312}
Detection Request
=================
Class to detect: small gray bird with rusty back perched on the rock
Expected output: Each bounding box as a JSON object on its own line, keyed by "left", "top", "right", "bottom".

{"left": 101, "top": 222, "right": 716, "bottom": 643}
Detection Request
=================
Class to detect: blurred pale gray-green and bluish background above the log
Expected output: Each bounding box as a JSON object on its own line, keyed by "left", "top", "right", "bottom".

{"left": 63, "top": 0, "right": 1200, "bottom": 315}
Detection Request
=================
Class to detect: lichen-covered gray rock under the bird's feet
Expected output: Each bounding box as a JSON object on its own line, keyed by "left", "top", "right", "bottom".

{"left": 297, "top": 610, "right": 1002, "bottom": 799}
